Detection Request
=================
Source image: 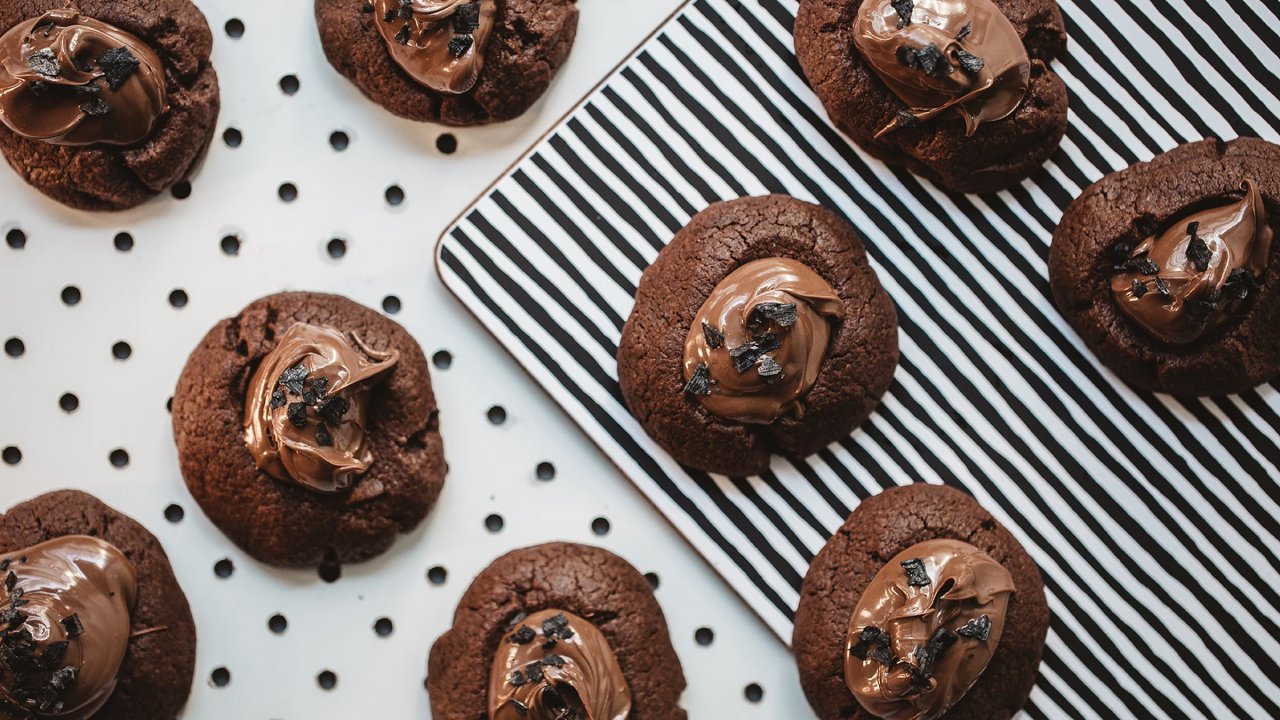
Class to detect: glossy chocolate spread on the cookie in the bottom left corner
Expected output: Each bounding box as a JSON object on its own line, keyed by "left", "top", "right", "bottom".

{"left": 0, "top": 536, "right": 137, "bottom": 720}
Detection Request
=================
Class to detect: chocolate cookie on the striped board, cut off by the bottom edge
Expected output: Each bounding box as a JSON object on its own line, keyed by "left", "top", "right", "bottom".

{"left": 791, "top": 484, "right": 1050, "bottom": 720}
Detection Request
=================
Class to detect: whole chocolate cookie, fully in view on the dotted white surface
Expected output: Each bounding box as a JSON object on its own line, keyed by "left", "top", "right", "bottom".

{"left": 173, "top": 292, "right": 445, "bottom": 566}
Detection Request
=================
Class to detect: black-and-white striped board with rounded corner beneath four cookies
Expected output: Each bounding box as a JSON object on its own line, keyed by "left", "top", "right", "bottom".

{"left": 439, "top": 0, "right": 1280, "bottom": 719}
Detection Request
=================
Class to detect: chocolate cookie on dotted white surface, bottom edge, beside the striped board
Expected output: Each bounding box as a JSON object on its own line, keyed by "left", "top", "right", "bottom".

{"left": 428, "top": 543, "right": 686, "bottom": 720}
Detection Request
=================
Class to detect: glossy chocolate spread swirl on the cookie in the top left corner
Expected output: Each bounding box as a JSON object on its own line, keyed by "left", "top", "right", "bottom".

{"left": 0, "top": 5, "right": 169, "bottom": 146}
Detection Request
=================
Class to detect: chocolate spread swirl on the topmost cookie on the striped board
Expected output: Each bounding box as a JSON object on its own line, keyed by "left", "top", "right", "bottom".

{"left": 854, "top": 0, "right": 1030, "bottom": 137}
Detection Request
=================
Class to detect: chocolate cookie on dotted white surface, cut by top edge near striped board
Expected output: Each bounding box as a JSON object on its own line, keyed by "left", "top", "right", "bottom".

{"left": 316, "top": 0, "right": 577, "bottom": 126}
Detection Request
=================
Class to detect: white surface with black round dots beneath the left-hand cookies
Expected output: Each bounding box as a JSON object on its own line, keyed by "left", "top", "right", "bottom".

{"left": 0, "top": 0, "right": 810, "bottom": 720}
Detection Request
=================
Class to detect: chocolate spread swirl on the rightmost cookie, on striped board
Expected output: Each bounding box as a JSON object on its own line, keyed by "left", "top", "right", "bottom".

{"left": 1111, "top": 181, "right": 1274, "bottom": 345}
